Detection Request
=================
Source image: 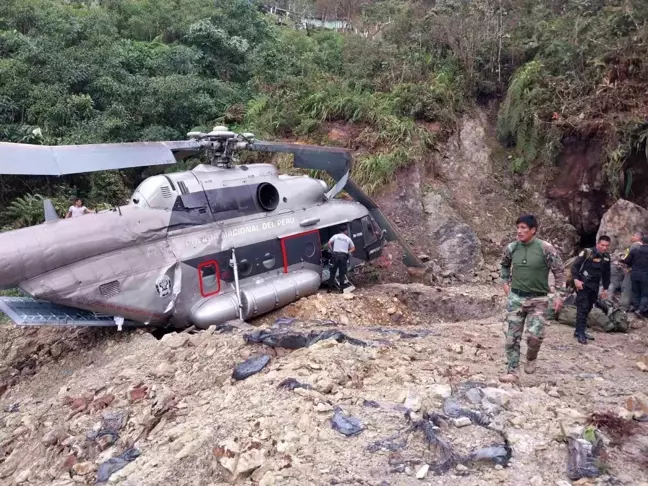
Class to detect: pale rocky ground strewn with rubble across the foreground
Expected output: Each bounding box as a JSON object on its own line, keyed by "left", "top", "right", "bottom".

{"left": 0, "top": 284, "right": 648, "bottom": 486}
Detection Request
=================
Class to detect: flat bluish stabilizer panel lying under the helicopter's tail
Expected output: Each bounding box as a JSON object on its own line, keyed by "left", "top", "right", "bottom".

{"left": 0, "top": 297, "right": 125, "bottom": 327}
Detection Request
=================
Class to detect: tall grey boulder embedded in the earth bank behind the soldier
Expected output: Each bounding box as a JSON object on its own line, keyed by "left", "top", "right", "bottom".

{"left": 423, "top": 192, "right": 484, "bottom": 279}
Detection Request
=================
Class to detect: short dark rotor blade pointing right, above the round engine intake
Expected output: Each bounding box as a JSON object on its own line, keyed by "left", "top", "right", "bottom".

{"left": 248, "top": 142, "right": 352, "bottom": 178}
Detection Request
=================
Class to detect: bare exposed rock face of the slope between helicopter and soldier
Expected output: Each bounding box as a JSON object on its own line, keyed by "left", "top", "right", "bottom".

{"left": 376, "top": 110, "right": 580, "bottom": 274}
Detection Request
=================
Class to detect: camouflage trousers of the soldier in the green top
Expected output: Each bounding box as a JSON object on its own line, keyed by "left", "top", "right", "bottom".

{"left": 504, "top": 292, "right": 549, "bottom": 371}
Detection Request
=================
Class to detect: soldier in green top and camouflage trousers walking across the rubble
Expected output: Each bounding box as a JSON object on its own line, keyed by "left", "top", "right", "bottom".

{"left": 500, "top": 215, "right": 565, "bottom": 383}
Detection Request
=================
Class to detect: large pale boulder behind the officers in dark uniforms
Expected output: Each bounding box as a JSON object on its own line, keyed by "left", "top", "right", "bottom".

{"left": 596, "top": 199, "right": 648, "bottom": 251}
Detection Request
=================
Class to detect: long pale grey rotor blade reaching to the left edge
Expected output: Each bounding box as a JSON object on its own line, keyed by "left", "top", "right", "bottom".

{"left": 0, "top": 140, "right": 201, "bottom": 175}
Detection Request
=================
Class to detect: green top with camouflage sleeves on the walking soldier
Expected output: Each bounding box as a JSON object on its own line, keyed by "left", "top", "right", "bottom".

{"left": 500, "top": 238, "right": 566, "bottom": 295}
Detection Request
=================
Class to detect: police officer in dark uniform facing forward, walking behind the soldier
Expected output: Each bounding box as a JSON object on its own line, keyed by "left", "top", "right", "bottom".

{"left": 572, "top": 236, "right": 610, "bottom": 344}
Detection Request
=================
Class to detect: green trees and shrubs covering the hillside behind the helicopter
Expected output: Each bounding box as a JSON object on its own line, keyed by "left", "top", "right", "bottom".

{"left": 0, "top": 0, "right": 648, "bottom": 227}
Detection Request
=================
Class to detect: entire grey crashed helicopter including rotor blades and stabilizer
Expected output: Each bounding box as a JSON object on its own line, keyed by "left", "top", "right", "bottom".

{"left": 0, "top": 126, "right": 423, "bottom": 330}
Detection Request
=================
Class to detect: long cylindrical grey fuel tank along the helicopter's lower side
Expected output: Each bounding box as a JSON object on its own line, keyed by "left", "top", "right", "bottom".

{"left": 190, "top": 270, "right": 321, "bottom": 329}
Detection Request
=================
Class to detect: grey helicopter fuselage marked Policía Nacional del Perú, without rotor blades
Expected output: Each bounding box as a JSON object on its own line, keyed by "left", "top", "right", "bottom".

{"left": 0, "top": 164, "right": 384, "bottom": 327}
